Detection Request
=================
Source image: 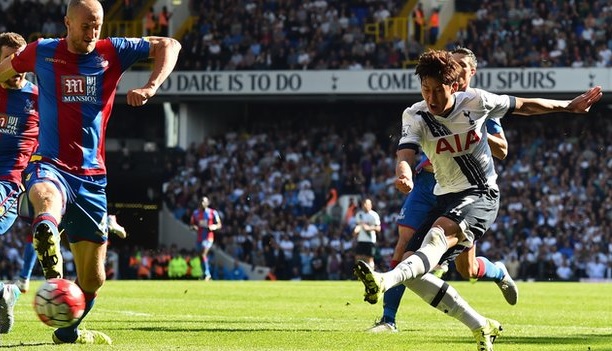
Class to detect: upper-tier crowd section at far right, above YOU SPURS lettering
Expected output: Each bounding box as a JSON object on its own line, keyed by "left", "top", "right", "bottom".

{"left": 457, "top": 0, "right": 612, "bottom": 67}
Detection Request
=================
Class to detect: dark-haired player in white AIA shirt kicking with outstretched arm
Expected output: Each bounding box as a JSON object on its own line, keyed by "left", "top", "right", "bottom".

{"left": 355, "top": 50, "right": 602, "bottom": 351}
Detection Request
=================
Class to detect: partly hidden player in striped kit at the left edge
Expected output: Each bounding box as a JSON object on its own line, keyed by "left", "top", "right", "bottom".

{"left": 0, "top": 33, "right": 38, "bottom": 334}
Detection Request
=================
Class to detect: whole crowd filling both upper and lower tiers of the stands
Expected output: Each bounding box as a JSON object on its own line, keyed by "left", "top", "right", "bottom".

{"left": 0, "top": 0, "right": 612, "bottom": 280}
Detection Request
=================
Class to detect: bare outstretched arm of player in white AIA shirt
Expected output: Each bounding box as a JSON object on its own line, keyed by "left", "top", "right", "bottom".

{"left": 514, "top": 86, "right": 603, "bottom": 115}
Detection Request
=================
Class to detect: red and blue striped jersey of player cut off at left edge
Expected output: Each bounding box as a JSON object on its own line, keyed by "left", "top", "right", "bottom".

{"left": 0, "top": 81, "right": 38, "bottom": 184}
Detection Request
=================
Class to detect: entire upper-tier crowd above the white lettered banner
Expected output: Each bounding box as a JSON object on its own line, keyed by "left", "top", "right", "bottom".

{"left": 0, "top": 0, "right": 612, "bottom": 71}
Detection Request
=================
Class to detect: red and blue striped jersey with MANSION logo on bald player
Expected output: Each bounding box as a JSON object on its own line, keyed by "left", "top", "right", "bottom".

{"left": 11, "top": 38, "right": 150, "bottom": 175}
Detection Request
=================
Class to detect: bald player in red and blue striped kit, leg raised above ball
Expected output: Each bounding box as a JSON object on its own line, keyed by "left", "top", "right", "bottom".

{"left": 0, "top": 0, "right": 180, "bottom": 344}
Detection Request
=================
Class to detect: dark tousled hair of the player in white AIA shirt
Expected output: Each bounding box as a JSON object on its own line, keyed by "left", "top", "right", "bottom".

{"left": 415, "top": 50, "right": 461, "bottom": 85}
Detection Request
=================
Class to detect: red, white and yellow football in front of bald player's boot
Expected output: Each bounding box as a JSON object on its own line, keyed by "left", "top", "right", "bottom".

{"left": 34, "top": 278, "right": 85, "bottom": 328}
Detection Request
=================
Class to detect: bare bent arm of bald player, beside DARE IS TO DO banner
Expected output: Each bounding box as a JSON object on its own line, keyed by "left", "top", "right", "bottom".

{"left": 127, "top": 37, "right": 181, "bottom": 106}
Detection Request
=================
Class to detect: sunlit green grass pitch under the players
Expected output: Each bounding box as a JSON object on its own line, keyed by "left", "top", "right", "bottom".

{"left": 0, "top": 281, "right": 612, "bottom": 351}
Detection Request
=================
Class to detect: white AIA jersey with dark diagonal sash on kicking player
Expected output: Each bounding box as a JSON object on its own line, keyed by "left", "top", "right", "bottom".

{"left": 399, "top": 89, "right": 516, "bottom": 195}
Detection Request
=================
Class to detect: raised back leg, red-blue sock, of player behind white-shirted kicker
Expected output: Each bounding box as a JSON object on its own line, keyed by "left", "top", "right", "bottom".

{"left": 455, "top": 243, "right": 518, "bottom": 305}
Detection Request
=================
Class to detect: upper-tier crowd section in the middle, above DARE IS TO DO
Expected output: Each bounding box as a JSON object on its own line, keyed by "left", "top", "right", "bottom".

{"left": 179, "top": 0, "right": 405, "bottom": 70}
